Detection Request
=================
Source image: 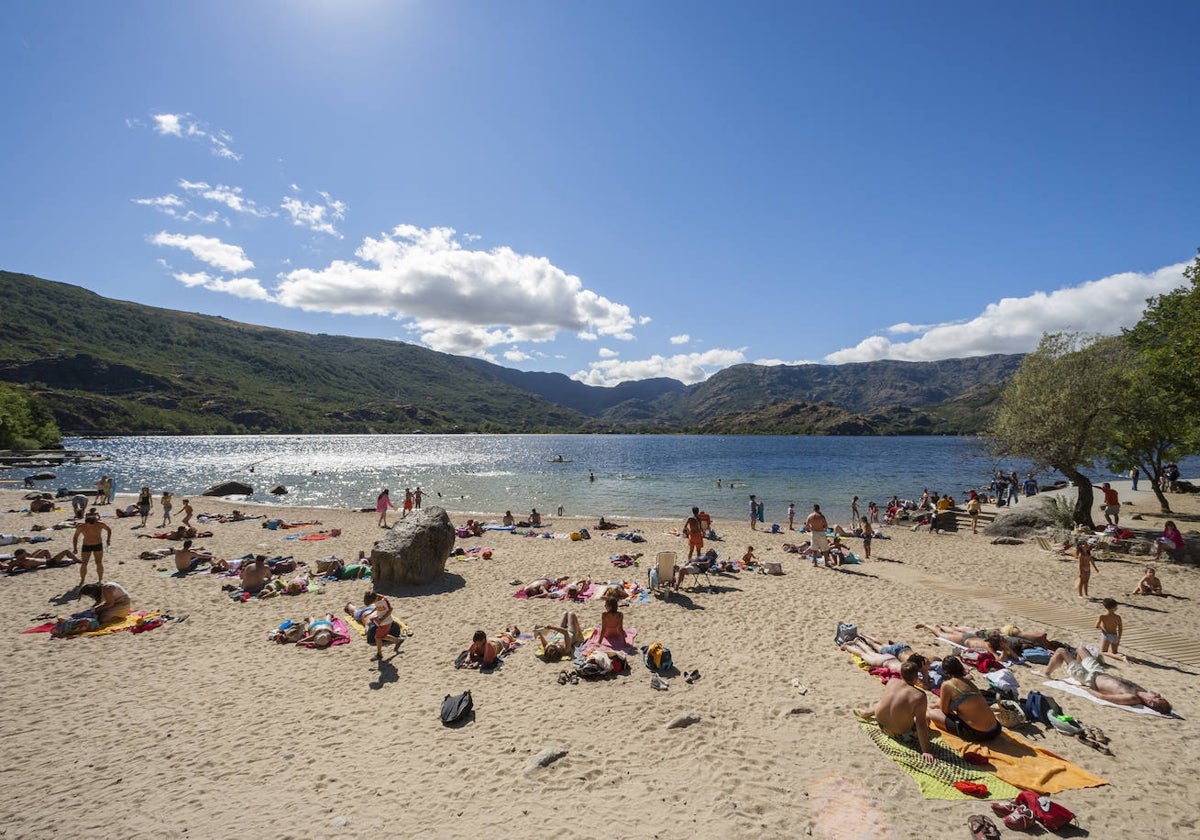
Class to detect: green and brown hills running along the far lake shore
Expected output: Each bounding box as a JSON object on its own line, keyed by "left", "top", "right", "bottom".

{"left": 0, "top": 271, "right": 1020, "bottom": 434}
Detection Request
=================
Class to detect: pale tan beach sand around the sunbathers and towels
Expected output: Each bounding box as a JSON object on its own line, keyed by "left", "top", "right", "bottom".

{"left": 0, "top": 488, "right": 1200, "bottom": 840}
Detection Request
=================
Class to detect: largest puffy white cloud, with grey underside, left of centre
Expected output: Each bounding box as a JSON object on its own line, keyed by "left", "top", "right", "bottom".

{"left": 275, "top": 224, "right": 635, "bottom": 358}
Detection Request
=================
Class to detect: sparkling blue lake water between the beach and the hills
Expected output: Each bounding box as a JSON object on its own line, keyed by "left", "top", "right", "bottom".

{"left": 28, "top": 434, "right": 1116, "bottom": 523}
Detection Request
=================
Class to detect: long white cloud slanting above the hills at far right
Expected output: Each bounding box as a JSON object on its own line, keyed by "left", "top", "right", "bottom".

{"left": 824, "top": 263, "right": 1188, "bottom": 365}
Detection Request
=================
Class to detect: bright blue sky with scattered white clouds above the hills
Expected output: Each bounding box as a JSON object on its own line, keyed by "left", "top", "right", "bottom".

{"left": 0, "top": 0, "right": 1200, "bottom": 384}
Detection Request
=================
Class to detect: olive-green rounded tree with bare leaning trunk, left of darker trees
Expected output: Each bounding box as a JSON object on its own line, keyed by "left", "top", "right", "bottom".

{"left": 983, "top": 332, "right": 1121, "bottom": 528}
